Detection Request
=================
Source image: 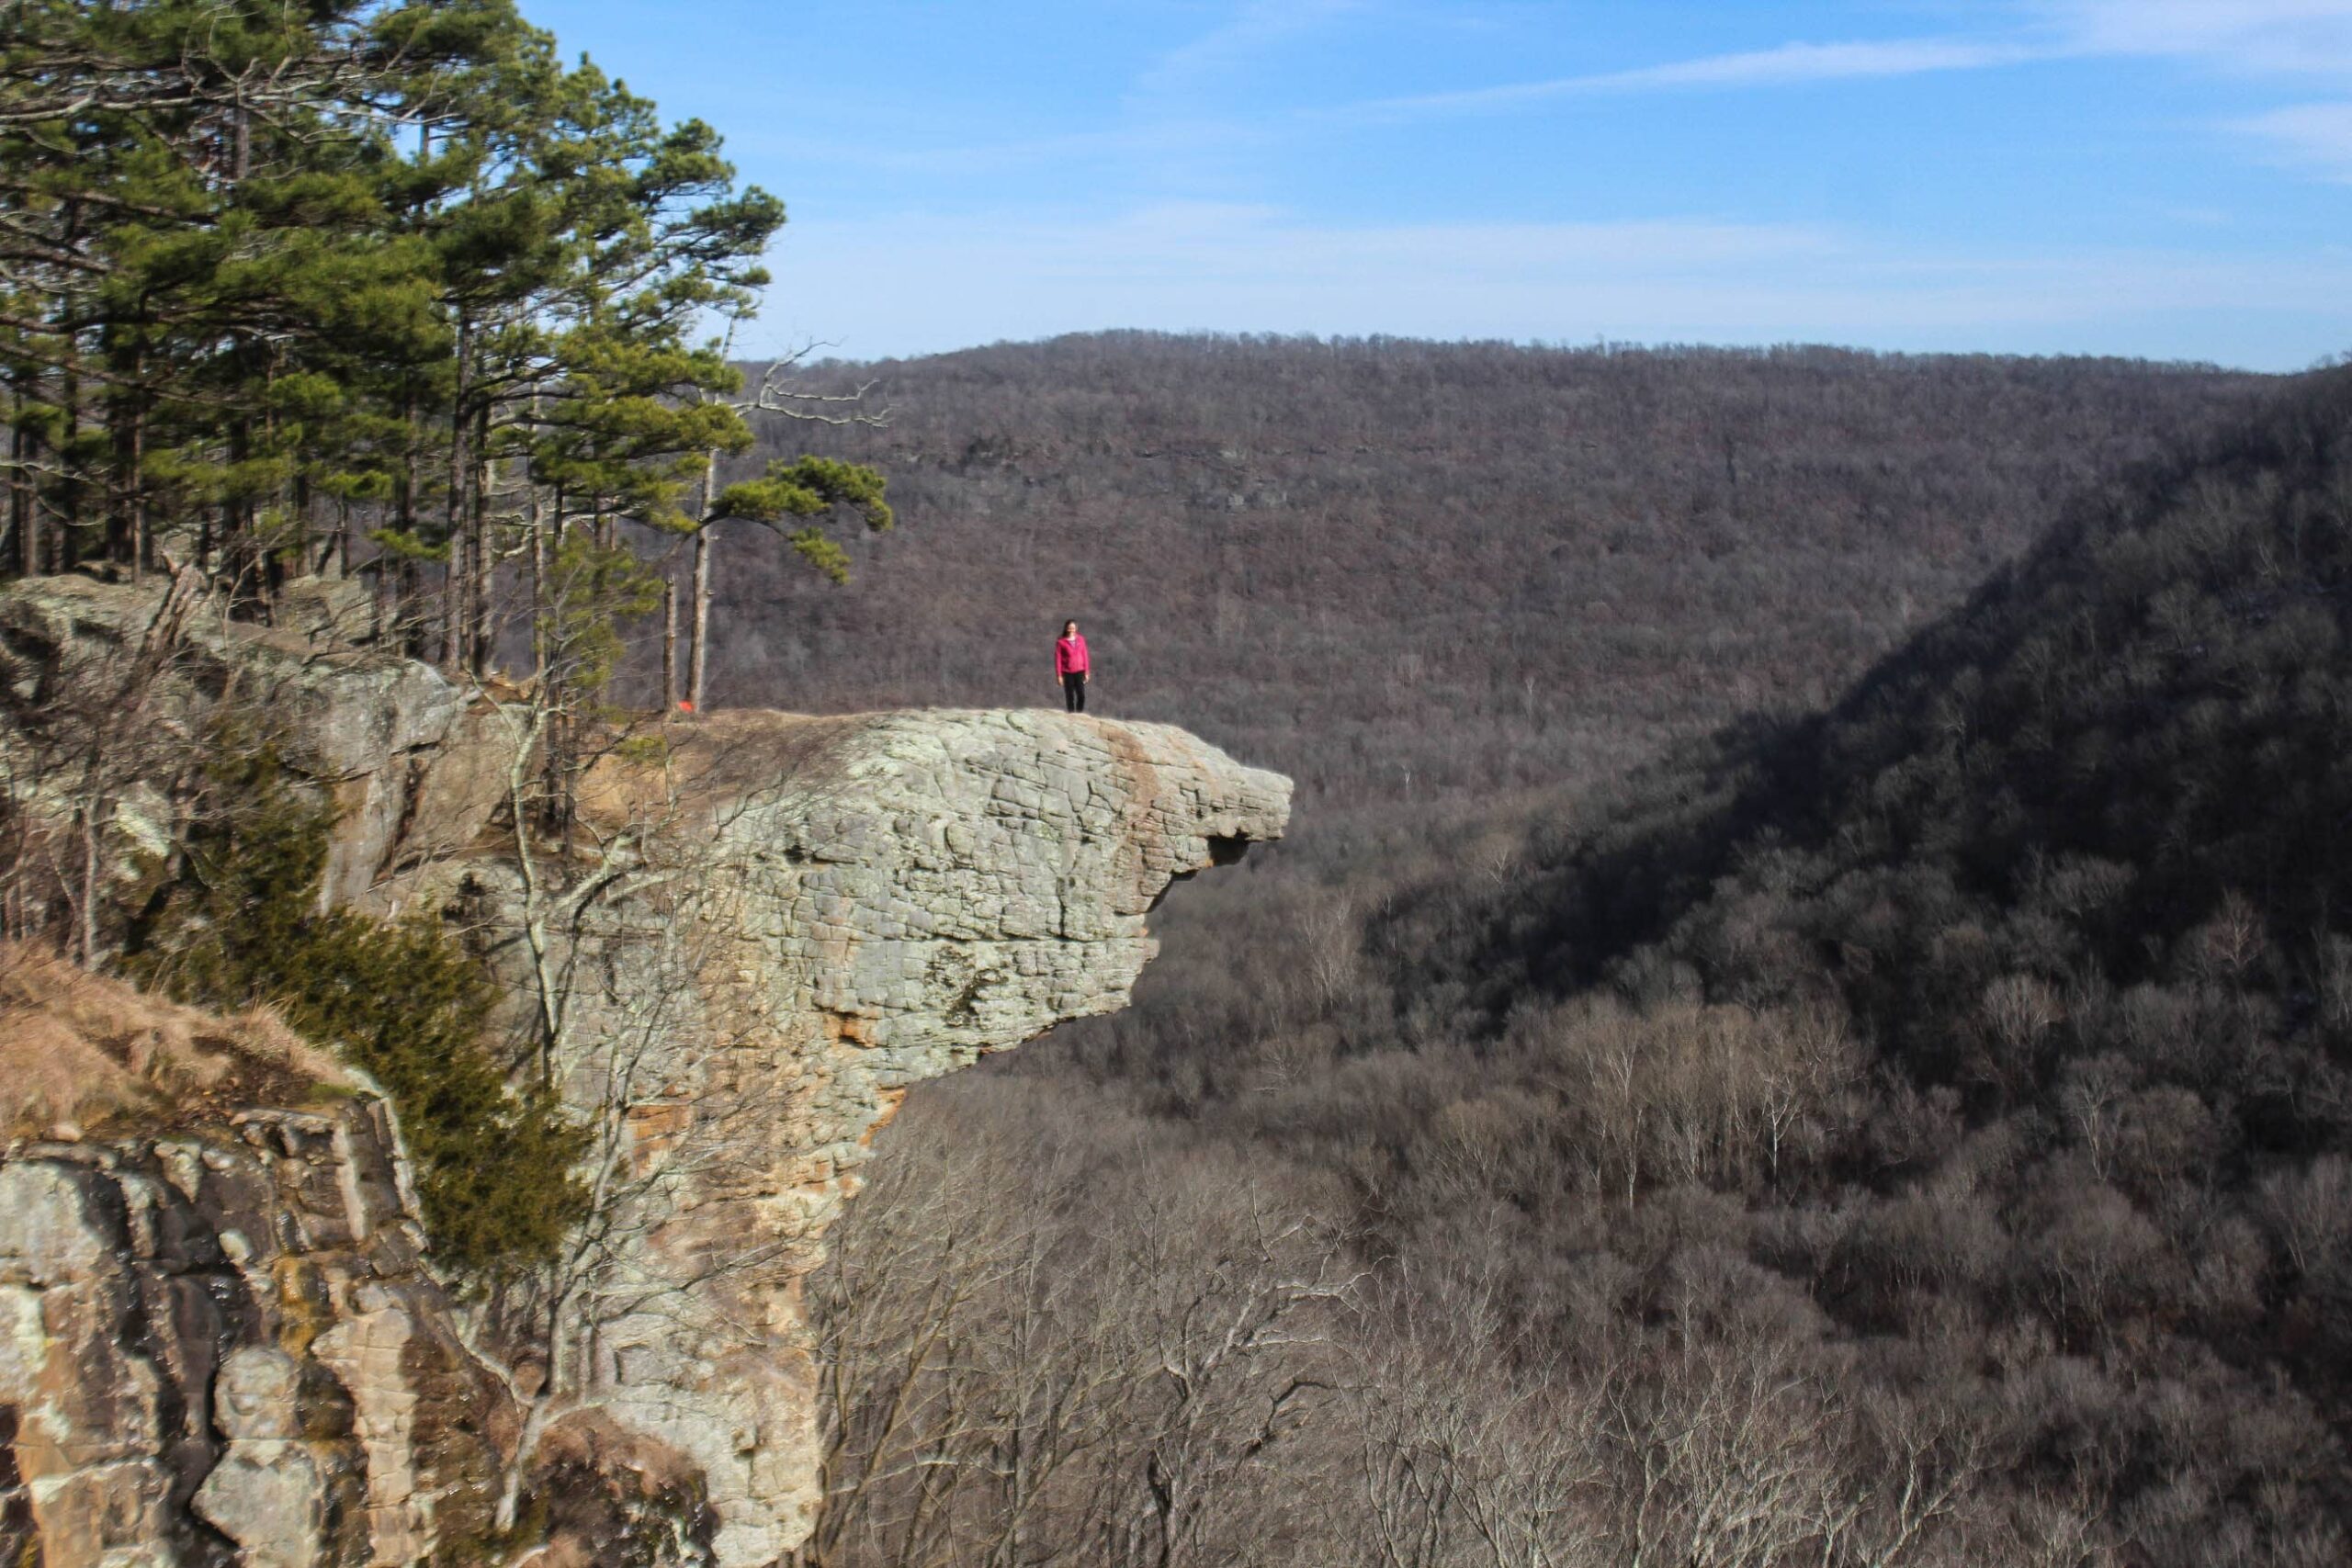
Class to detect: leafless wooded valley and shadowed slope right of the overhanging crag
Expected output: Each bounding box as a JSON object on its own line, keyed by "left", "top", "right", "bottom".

{"left": 786, "top": 350, "right": 2352, "bottom": 1568}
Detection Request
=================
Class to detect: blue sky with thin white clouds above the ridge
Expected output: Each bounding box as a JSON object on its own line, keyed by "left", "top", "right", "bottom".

{"left": 525, "top": 0, "right": 2352, "bottom": 369}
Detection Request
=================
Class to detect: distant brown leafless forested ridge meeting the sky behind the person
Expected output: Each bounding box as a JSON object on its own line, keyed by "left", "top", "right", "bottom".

{"left": 713, "top": 333, "right": 2258, "bottom": 822}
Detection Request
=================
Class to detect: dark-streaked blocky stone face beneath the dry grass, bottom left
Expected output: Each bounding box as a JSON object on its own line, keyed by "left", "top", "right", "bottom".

{"left": 0, "top": 1096, "right": 513, "bottom": 1568}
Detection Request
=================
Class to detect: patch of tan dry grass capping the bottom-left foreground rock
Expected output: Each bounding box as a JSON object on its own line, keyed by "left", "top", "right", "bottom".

{"left": 0, "top": 942, "right": 350, "bottom": 1138}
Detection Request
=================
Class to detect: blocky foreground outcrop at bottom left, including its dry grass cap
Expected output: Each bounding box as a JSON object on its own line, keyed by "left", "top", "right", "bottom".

{"left": 0, "top": 945, "right": 515, "bottom": 1568}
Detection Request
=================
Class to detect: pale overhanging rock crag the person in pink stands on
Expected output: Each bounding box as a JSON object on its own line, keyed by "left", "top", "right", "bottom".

{"left": 448, "top": 712, "right": 1286, "bottom": 1563}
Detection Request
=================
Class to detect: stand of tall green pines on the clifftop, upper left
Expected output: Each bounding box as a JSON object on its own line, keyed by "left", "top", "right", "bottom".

{"left": 0, "top": 0, "right": 879, "bottom": 674}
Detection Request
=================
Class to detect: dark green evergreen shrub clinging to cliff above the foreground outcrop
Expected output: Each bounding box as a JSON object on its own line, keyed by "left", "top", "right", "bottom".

{"left": 127, "top": 736, "right": 585, "bottom": 1279}
